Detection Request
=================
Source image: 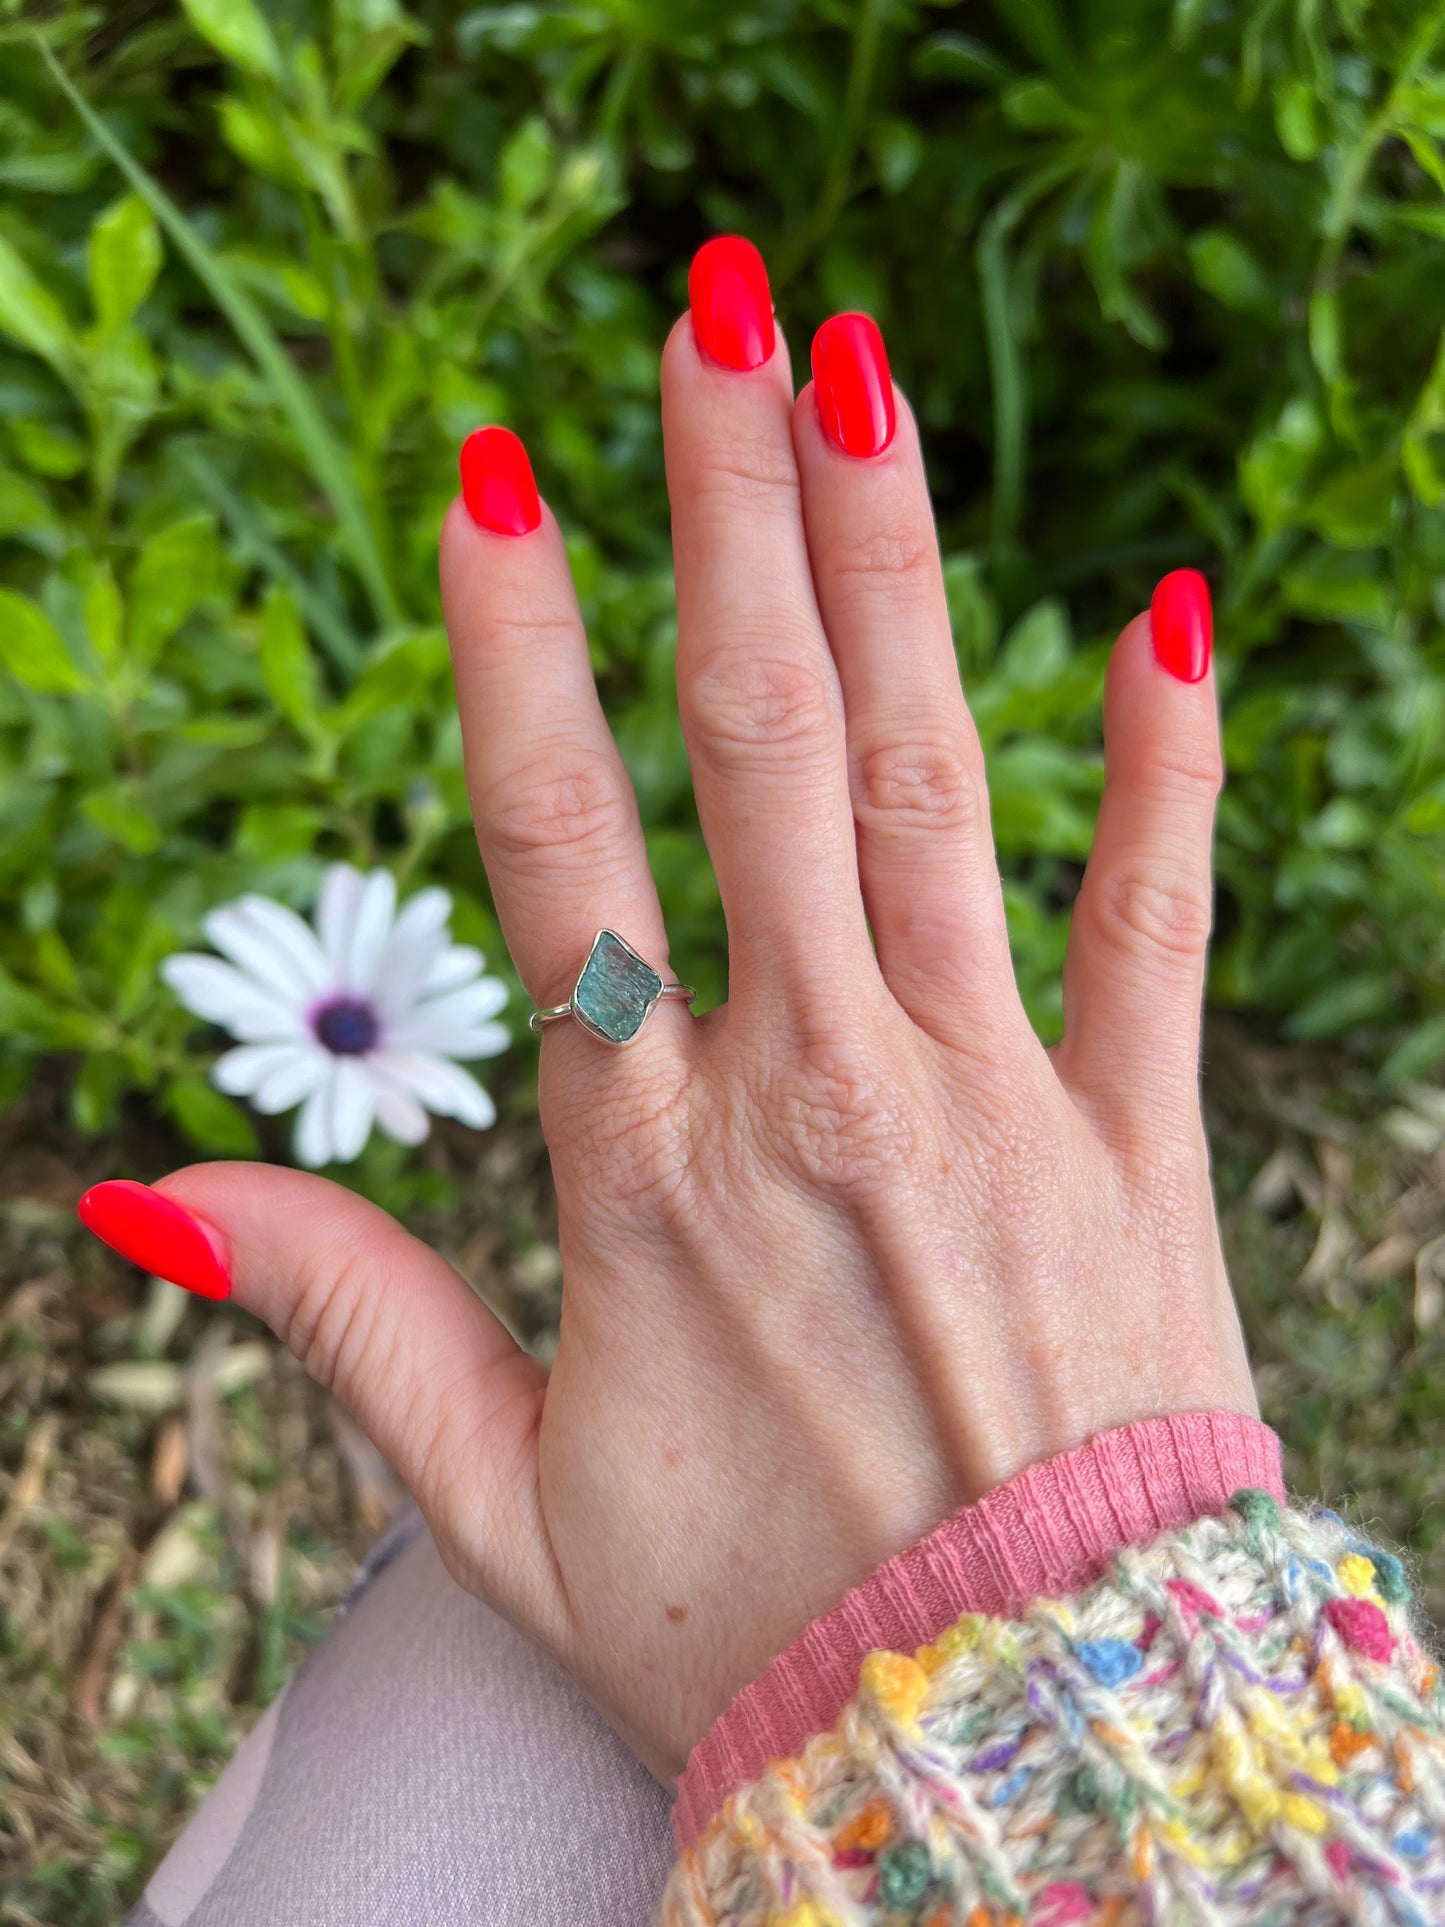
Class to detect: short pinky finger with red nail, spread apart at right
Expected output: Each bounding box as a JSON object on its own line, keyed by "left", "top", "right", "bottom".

{"left": 1054, "top": 568, "right": 1223, "bottom": 1148}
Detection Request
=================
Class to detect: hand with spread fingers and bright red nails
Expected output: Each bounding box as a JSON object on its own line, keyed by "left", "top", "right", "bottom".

{"left": 99, "top": 245, "right": 1254, "bottom": 1779}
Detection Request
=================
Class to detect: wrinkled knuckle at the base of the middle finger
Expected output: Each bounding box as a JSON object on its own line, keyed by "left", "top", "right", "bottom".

{"left": 765, "top": 1027, "right": 913, "bottom": 1195}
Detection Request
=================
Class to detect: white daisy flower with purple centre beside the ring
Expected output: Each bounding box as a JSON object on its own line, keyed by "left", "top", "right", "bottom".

{"left": 160, "top": 863, "right": 511, "bottom": 1166}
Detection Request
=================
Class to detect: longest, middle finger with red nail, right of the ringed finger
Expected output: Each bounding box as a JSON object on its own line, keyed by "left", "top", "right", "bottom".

{"left": 663, "top": 237, "right": 871, "bottom": 1002}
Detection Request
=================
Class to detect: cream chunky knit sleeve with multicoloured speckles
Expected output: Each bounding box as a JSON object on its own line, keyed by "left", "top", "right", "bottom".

{"left": 661, "top": 1491, "right": 1445, "bottom": 1927}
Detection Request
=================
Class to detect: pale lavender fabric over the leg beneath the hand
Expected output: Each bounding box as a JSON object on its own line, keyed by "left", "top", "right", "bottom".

{"left": 129, "top": 1513, "right": 672, "bottom": 1927}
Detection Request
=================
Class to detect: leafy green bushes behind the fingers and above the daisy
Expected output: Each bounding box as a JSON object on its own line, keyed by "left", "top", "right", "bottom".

{"left": 0, "top": 0, "right": 1445, "bottom": 1152}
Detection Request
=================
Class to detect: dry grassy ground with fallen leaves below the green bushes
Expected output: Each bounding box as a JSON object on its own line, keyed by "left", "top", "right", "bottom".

{"left": 0, "top": 1023, "right": 1445, "bottom": 1927}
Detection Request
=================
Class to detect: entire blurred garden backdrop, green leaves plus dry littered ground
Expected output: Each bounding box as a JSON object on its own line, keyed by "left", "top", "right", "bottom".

{"left": 0, "top": 0, "right": 1445, "bottom": 1927}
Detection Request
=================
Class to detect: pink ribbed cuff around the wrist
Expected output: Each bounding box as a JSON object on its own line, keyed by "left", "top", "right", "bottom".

{"left": 672, "top": 1412, "right": 1285, "bottom": 1848}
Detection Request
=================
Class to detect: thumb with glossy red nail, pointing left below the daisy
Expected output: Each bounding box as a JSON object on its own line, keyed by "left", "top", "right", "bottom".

{"left": 79, "top": 1164, "right": 549, "bottom": 1624}
